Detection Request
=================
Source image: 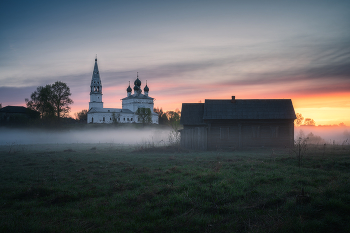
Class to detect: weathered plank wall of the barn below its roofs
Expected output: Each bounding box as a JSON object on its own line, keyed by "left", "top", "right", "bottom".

{"left": 181, "top": 120, "right": 294, "bottom": 150}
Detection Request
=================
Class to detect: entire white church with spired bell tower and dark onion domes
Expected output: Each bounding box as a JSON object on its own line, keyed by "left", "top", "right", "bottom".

{"left": 87, "top": 58, "right": 158, "bottom": 124}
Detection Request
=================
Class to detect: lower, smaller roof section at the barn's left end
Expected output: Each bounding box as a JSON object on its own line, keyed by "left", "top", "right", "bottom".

{"left": 180, "top": 103, "right": 205, "bottom": 125}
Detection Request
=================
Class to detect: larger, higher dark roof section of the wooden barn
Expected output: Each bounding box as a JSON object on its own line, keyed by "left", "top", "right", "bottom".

{"left": 203, "top": 99, "right": 296, "bottom": 120}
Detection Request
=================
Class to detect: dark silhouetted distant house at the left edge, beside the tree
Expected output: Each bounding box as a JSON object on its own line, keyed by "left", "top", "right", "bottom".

{"left": 0, "top": 106, "right": 40, "bottom": 124}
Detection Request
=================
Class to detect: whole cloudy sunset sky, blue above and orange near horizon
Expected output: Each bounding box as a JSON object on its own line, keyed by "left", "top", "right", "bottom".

{"left": 0, "top": 0, "right": 350, "bottom": 125}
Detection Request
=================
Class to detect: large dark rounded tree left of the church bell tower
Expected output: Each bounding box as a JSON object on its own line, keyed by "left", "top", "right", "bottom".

{"left": 25, "top": 81, "right": 73, "bottom": 118}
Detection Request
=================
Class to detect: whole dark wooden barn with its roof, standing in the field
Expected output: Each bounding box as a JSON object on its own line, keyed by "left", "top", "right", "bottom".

{"left": 181, "top": 96, "right": 296, "bottom": 150}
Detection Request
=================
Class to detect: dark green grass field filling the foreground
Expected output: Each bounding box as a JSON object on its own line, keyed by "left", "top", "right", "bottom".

{"left": 0, "top": 144, "right": 350, "bottom": 232}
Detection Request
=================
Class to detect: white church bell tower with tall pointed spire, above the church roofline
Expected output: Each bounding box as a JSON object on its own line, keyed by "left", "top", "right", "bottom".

{"left": 89, "top": 57, "right": 103, "bottom": 109}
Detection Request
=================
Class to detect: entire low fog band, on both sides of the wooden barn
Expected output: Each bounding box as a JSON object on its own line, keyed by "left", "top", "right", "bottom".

{"left": 0, "top": 126, "right": 350, "bottom": 145}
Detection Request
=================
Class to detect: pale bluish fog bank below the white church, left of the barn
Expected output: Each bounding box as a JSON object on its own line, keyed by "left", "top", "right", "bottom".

{"left": 0, "top": 127, "right": 171, "bottom": 145}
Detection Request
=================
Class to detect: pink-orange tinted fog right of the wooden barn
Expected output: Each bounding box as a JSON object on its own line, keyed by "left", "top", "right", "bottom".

{"left": 294, "top": 126, "right": 350, "bottom": 144}
